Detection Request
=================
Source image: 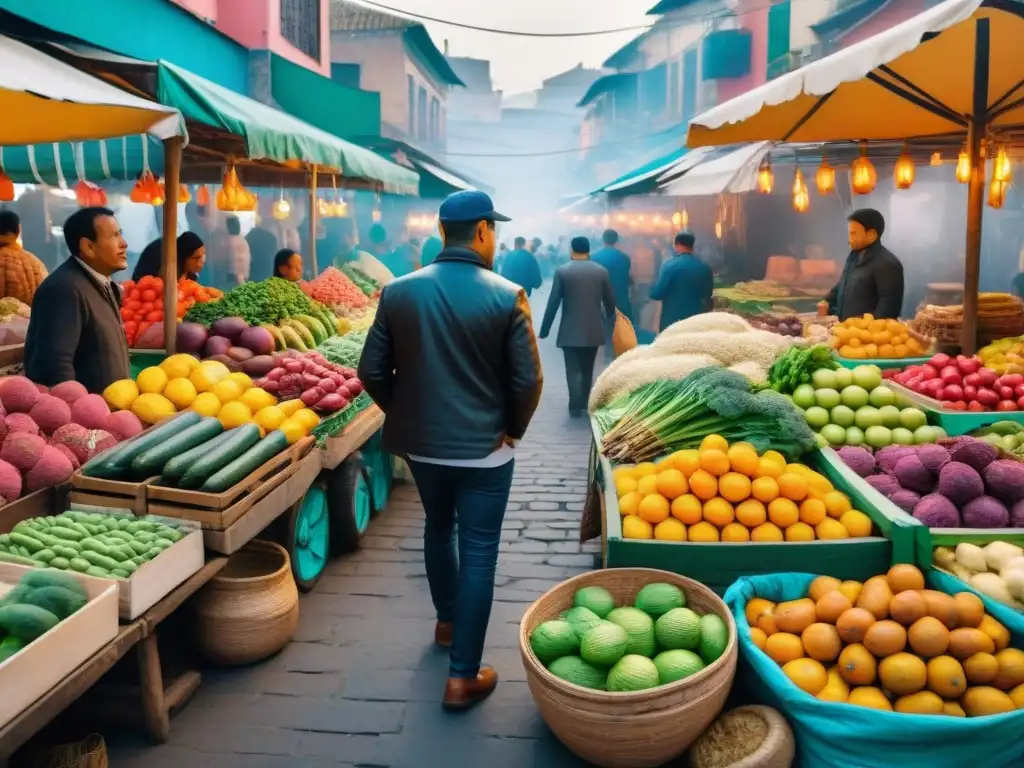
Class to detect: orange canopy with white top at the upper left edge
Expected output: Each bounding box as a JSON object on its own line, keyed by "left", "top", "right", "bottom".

{"left": 0, "top": 36, "right": 184, "bottom": 146}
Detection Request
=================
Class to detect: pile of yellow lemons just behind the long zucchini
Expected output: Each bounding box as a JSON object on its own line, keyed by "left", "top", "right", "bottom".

{"left": 103, "top": 354, "right": 319, "bottom": 442}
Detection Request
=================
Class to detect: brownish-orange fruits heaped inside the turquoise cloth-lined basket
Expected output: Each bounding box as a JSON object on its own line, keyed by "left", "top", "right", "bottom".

{"left": 745, "top": 565, "right": 1024, "bottom": 717}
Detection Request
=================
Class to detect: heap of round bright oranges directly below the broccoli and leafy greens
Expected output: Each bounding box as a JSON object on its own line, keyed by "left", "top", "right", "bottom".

{"left": 613, "top": 435, "right": 871, "bottom": 542}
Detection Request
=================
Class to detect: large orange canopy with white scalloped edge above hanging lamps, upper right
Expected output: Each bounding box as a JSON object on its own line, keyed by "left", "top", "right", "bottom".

{"left": 687, "top": 0, "right": 1024, "bottom": 146}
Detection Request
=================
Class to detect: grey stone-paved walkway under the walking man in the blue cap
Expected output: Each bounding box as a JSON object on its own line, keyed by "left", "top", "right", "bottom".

{"left": 104, "top": 294, "right": 599, "bottom": 768}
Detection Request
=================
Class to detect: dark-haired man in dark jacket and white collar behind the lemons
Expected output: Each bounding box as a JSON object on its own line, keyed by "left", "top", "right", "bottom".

{"left": 25, "top": 208, "right": 131, "bottom": 394}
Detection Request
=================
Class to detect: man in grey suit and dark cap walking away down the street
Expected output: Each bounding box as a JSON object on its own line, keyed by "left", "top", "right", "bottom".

{"left": 541, "top": 238, "right": 615, "bottom": 417}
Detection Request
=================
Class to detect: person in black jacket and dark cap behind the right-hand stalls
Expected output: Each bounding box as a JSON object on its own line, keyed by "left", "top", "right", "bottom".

{"left": 825, "top": 208, "right": 903, "bottom": 321}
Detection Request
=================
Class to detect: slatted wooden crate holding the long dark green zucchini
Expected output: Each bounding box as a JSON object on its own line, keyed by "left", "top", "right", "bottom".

{"left": 147, "top": 437, "right": 316, "bottom": 530}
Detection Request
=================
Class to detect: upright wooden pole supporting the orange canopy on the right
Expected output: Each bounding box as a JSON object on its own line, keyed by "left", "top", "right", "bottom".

{"left": 961, "top": 18, "right": 989, "bottom": 354}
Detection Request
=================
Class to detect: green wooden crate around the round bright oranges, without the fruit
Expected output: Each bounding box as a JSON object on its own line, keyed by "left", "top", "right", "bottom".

{"left": 594, "top": 417, "right": 920, "bottom": 594}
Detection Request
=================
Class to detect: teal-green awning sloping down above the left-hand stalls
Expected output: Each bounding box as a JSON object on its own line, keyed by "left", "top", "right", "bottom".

{"left": 157, "top": 60, "right": 419, "bottom": 195}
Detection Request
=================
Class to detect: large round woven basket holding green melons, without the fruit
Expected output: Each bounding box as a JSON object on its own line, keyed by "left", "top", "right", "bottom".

{"left": 519, "top": 568, "right": 737, "bottom": 768}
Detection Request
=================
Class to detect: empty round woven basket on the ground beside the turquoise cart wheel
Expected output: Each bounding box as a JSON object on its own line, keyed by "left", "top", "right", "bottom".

{"left": 196, "top": 540, "right": 299, "bottom": 665}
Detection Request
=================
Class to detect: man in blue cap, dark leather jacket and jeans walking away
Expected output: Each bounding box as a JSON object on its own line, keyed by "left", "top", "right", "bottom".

{"left": 359, "top": 190, "right": 543, "bottom": 709}
